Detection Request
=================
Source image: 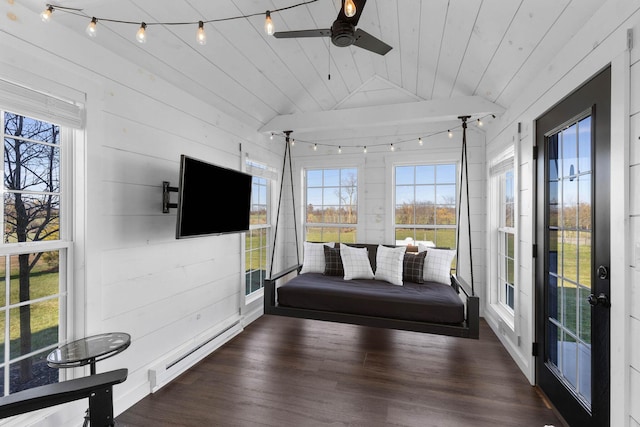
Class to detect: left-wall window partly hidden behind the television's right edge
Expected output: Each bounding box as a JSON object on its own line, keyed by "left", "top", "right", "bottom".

{"left": 245, "top": 161, "right": 271, "bottom": 295}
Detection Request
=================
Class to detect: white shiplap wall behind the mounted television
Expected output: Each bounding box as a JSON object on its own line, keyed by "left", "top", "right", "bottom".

{"left": 0, "top": 2, "right": 280, "bottom": 426}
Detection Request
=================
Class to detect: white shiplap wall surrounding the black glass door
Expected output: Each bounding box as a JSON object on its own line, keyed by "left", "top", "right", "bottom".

{"left": 485, "top": 0, "right": 640, "bottom": 426}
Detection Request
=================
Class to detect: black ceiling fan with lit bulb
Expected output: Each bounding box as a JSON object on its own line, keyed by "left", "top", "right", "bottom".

{"left": 273, "top": 0, "right": 392, "bottom": 55}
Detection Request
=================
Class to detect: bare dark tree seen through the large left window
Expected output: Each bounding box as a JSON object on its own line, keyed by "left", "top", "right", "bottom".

{"left": 4, "top": 112, "right": 60, "bottom": 381}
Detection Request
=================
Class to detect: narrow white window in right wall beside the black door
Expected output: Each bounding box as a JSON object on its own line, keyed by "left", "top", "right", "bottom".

{"left": 498, "top": 169, "right": 515, "bottom": 310}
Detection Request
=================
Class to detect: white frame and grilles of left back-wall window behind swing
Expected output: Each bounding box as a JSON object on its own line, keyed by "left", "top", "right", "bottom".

{"left": 302, "top": 165, "right": 361, "bottom": 243}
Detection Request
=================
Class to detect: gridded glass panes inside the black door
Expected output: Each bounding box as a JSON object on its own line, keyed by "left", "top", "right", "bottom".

{"left": 546, "top": 116, "right": 593, "bottom": 409}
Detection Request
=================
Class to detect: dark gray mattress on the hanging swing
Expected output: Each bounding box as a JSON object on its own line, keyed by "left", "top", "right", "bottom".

{"left": 277, "top": 273, "right": 464, "bottom": 324}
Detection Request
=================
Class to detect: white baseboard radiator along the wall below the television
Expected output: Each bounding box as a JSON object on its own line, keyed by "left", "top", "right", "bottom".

{"left": 149, "top": 317, "right": 243, "bottom": 393}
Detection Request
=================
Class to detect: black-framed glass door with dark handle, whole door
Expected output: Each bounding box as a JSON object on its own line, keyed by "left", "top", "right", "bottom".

{"left": 534, "top": 68, "right": 611, "bottom": 427}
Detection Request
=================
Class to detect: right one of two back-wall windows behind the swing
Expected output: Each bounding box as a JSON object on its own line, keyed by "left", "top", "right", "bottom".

{"left": 394, "top": 164, "right": 457, "bottom": 248}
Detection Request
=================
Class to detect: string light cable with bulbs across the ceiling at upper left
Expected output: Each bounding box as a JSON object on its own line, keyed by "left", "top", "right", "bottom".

{"left": 40, "top": 0, "right": 318, "bottom": 39}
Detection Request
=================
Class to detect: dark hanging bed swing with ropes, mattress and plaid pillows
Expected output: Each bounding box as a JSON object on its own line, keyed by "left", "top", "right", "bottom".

{"left": 264, "top": 116, "right": 480, "bottom": 339}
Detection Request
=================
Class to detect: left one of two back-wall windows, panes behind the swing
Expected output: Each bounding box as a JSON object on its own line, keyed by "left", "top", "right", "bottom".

{"left": 305, "top": 168, "right": 358, "bottom": 243}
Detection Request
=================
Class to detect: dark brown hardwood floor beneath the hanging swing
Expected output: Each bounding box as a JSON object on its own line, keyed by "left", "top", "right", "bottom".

{"left": 117, "top": 316, "right": 563, "bottom": 427}
